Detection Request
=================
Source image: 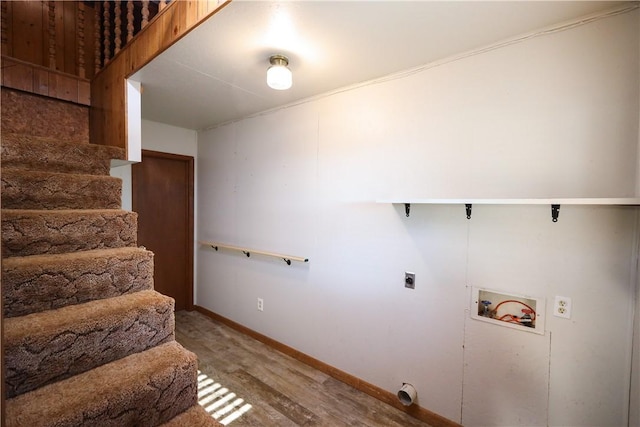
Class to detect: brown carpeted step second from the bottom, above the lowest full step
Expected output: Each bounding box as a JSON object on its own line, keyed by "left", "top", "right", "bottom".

{"left": 3, "top": 290, "right": 174, "bottom": 397}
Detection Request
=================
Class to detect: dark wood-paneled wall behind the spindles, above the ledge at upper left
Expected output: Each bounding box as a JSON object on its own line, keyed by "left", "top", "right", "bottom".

{"left": 0, "top": 0, "right": 96, "bottom": 78}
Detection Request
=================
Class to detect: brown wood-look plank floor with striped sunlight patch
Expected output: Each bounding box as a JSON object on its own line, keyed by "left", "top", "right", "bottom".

{"left": 176, "top": 311, "right": 427, "bottom": 427}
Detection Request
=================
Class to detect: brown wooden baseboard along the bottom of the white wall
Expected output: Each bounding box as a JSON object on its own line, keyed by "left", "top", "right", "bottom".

{"left": 194, "top": 305, "right": 462, "bottom": 427}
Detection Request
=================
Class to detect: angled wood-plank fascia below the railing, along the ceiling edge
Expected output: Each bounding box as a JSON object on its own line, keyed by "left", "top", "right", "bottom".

{"left": 90, "top": 0, "right": 230, "bottom": 149}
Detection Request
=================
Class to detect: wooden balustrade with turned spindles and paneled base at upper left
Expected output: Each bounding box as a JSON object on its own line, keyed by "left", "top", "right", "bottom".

{"left": 0, "top": 0, "right": 168, "bottom": 105}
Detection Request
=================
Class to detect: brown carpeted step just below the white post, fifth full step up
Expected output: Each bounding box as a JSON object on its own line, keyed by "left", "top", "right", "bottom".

{"left": 2, "top": 166, "right": 122, "bottom": 209}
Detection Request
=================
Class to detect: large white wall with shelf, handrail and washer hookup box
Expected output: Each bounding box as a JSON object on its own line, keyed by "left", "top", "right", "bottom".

{"left": 197, "top": 11, "right": 640, "bottom": 426}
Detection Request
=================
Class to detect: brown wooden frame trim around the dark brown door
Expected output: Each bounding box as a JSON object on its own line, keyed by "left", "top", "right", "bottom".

{"left": 131, "top": 150, "right": 195, "bottom": 311}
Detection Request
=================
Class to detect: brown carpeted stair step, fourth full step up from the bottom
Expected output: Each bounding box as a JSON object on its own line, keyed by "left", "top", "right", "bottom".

{"left": 2, "top": 209, "right": 138, "bottom": 258}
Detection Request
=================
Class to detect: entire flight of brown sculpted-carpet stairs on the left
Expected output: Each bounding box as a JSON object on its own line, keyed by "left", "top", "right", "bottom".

{"left": 1, "top": 88, "right": 219, "bottom": 427}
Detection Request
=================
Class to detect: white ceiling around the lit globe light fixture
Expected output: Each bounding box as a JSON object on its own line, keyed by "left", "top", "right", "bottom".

{"left": 132, "top": 0, "right": 624, "bottom": 129}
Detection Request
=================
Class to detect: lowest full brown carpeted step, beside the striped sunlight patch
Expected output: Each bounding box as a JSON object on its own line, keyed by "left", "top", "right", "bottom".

{"left": 6, "top": 341, "right": 197, "bottom": 427}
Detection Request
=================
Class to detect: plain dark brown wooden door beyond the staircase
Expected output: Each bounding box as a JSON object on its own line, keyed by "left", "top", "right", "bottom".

{"left": 131, "top": 150, "right": 193, "bottom": 311}
